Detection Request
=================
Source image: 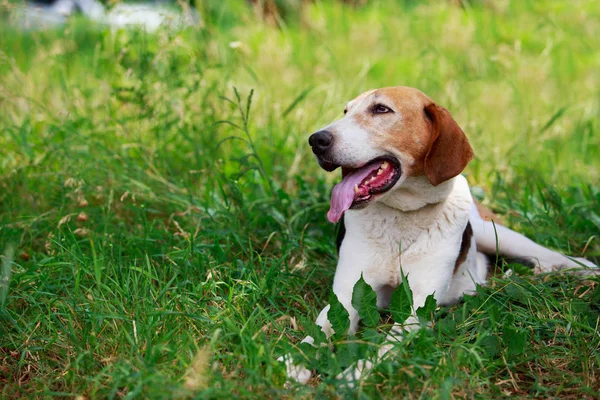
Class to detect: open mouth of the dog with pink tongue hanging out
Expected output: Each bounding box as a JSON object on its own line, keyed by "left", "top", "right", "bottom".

{"left": 327, "top": 156, "right": 400, "bottom": 223}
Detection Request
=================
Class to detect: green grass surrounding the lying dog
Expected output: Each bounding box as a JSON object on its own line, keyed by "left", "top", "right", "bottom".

{"left": 0, "top": 0, "right": 600, "bottom": 399}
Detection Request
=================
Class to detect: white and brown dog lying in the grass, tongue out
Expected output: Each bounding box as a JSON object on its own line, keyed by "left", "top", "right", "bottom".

{"left": 280, "top": 87, "right": 598, "bottom": 383}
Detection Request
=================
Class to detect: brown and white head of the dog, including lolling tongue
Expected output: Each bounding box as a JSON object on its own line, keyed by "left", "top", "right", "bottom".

{"left": 309, "top": 87, "right": 473, "bottom": 222}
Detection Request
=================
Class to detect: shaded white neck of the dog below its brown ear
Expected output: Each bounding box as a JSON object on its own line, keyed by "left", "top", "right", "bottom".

{"left": 381, "top": 176, "right": 456, "bottom": 212}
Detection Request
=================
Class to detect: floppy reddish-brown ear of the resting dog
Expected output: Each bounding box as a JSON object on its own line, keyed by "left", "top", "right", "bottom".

{"left": 424, "top": 103, "right": 473, "bottom": 186}
